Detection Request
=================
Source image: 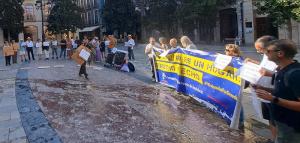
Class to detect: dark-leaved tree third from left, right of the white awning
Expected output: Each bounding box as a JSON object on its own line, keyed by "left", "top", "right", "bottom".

{"left": 103, "top": 0, "right": 138, "bottom": 34}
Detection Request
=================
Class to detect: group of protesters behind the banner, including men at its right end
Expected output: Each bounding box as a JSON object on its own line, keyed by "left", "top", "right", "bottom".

{"left": 145, "top": 36, "right": 300, "bottom": 143}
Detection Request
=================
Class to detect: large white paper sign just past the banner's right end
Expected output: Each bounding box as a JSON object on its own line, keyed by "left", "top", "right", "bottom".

{"left": 239, "top": 62, "right": 262, "bottom": 84}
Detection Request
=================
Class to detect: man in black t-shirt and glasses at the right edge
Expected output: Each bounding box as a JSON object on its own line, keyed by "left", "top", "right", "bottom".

{"left": 256, "top": 40, "right": 300, "bottom": 143}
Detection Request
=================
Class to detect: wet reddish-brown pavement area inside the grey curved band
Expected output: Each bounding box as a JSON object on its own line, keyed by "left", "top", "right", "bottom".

{"left": 30, "top": 79, "right": 265, "bottom": 143}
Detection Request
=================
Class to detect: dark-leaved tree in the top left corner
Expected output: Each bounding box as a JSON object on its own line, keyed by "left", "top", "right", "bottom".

{"left": 0, "top": 0, "right": 24, "bottom": 38}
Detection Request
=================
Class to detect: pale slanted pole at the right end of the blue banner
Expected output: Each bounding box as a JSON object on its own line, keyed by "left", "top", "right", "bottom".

{"left": 230, "top": 80, "right": 245, "bottom": 130}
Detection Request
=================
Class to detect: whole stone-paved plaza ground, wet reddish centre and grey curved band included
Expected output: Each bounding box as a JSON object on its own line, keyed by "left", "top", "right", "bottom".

{"left": 0, "top": 45, "right": 298, "bottom": 143}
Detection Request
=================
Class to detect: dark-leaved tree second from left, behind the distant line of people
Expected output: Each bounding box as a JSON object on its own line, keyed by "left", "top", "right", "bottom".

{"left": 48, "top": 0, "right": 83, "bottom": 34}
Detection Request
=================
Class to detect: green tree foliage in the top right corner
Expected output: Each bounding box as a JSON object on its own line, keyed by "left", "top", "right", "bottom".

{"left": 255, "top": 0, "right": 300, "bottom": 39}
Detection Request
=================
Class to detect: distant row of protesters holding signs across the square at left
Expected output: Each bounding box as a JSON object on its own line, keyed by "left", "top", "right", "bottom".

{"left": 3, "top": 35, "right": 135, "bottom": 66}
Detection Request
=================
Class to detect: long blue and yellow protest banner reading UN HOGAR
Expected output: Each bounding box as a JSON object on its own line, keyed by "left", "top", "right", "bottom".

{"left": 153, "top": 48, "right": 242, "bottom": 124}
